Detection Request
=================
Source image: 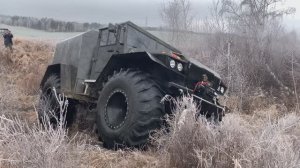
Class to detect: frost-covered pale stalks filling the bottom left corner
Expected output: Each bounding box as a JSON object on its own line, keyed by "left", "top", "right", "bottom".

{"left": 0, "top": 90, "right": 86, "bottom": 168}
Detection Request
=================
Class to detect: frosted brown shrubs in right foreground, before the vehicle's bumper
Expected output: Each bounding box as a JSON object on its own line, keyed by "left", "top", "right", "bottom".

{"left": 155, "top": 97, "right": 300, "bottom": 168}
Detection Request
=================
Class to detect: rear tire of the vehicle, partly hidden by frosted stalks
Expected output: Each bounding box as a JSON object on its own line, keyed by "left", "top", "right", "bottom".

{"left": 38, "top": 75, "right": 60, "bottom": 124}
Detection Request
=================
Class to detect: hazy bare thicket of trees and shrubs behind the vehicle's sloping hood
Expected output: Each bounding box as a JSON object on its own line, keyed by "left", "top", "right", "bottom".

{"left": 161, "top": 0, "right": 300, "bottom": 111}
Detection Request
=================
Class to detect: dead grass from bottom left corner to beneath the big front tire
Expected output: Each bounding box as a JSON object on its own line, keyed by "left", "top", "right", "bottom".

{"left": 0, "top": 86, "right": 159, "bottom": 168}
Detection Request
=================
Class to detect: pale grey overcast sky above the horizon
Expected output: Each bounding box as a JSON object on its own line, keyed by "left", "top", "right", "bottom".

{"left": 0, "top": 0, "right": 300, "bottom": 29}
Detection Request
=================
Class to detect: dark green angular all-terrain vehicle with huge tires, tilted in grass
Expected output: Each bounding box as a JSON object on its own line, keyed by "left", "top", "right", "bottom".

{"left": 41, "top": 22, "right": 226, "bottom": 147}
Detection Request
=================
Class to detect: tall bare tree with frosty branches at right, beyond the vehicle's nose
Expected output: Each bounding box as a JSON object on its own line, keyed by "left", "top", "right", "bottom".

{"left": 195, "top": 0, "right": 300, "bottom": 111}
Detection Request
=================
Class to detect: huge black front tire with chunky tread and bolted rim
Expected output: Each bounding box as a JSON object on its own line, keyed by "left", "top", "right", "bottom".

{"left": 96, "top": 69, "right": 164, "bottom": 148}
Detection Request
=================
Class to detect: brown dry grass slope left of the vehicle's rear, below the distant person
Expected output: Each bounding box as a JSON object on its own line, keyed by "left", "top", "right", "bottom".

{"left": 0, "top": 39, "right": 53, "bottom": 118}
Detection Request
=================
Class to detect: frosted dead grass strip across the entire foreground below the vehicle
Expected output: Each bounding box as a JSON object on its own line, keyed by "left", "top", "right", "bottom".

{"left": 0, "top": 94, "right": 300, "bottom": 168}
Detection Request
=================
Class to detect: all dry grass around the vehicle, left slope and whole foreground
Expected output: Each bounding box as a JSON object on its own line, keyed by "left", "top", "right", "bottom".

{"left": 0, "top": 40, "right": 300, "bottom": 168}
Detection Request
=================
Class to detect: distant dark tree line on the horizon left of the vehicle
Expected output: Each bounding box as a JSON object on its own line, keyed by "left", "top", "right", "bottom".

{"left": 0, "top": 15, "right": 103, "bottom": 32}
